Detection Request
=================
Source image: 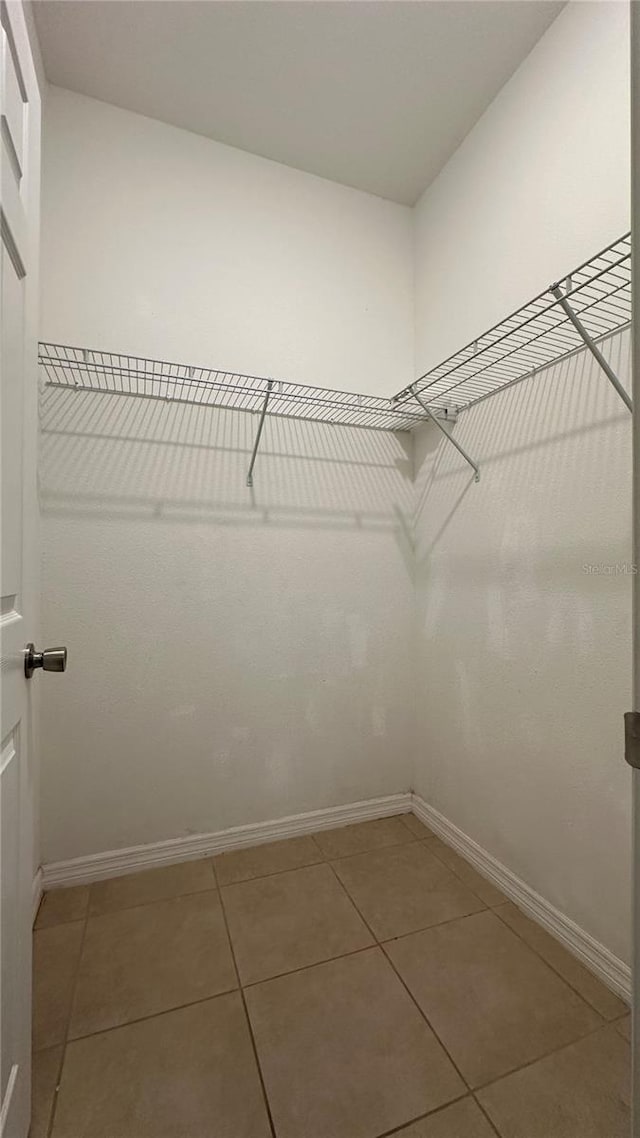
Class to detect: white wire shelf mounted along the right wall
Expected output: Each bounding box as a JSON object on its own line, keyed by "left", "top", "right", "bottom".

{"left": 394, "top": 233, "right": 631, "bottom": 411}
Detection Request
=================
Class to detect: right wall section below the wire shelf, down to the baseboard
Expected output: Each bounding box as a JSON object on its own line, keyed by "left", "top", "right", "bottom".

{"left": 407, "top": 332, "right": 633, "bottom": 958}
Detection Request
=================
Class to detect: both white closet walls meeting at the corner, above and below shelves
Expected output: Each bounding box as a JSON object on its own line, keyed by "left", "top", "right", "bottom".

{"left": 42, "top": 3, "right": 631, "bottom": 974}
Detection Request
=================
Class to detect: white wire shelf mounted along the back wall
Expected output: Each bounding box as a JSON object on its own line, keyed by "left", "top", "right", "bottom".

{"left": 39, "top": 344, "right": 427, "bottom": 431}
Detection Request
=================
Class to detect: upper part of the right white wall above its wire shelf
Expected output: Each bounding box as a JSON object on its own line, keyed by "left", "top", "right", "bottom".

{"left": 416, "top": 0, "right": 630, "bottom": 374}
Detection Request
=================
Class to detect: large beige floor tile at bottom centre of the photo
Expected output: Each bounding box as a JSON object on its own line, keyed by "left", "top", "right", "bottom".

{"left": 244, "top": 948, "right": 465, "bottom": 1138}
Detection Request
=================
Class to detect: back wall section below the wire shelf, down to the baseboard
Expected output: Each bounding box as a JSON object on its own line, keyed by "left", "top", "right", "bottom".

{"left": 41, "top": 389, "right": 413, "bottom": 861}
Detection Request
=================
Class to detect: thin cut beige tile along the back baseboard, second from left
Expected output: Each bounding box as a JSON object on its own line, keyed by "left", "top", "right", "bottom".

{"left": 89, "top": 858, "right": 215, "bottom": 916}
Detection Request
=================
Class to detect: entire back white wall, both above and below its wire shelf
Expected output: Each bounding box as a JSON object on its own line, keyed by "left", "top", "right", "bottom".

{"left": 41, "top": 90, "right": 413, "bottom": 861}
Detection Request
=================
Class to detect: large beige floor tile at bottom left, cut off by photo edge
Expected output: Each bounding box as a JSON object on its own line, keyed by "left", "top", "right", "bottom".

{"left": 54, "top": 992, "right": 271, "bottom": 1138}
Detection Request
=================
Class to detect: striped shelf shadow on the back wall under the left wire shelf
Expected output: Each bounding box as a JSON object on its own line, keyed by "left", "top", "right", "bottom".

{"left": 41, "top": 387, "right": 412, "bottom": 549}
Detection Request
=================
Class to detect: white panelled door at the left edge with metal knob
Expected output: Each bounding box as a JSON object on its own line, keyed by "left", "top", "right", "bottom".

{"left": 0, "top": 0, "right": 40, "bottom": 1138}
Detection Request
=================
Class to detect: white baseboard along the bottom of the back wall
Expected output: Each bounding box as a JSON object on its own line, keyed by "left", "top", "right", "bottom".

{"left": 40, "top": 791, "right": 411, "bottom": 889}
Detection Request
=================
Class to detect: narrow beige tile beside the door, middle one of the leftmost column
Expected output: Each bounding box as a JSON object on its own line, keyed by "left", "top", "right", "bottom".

{"left": 33, "top": 921, "right": 84, "bottom": 1050}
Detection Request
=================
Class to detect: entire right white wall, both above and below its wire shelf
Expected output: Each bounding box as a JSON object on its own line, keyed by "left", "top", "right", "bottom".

{"left": 416, "top": 3, "right": 631, "bottom": 958}
